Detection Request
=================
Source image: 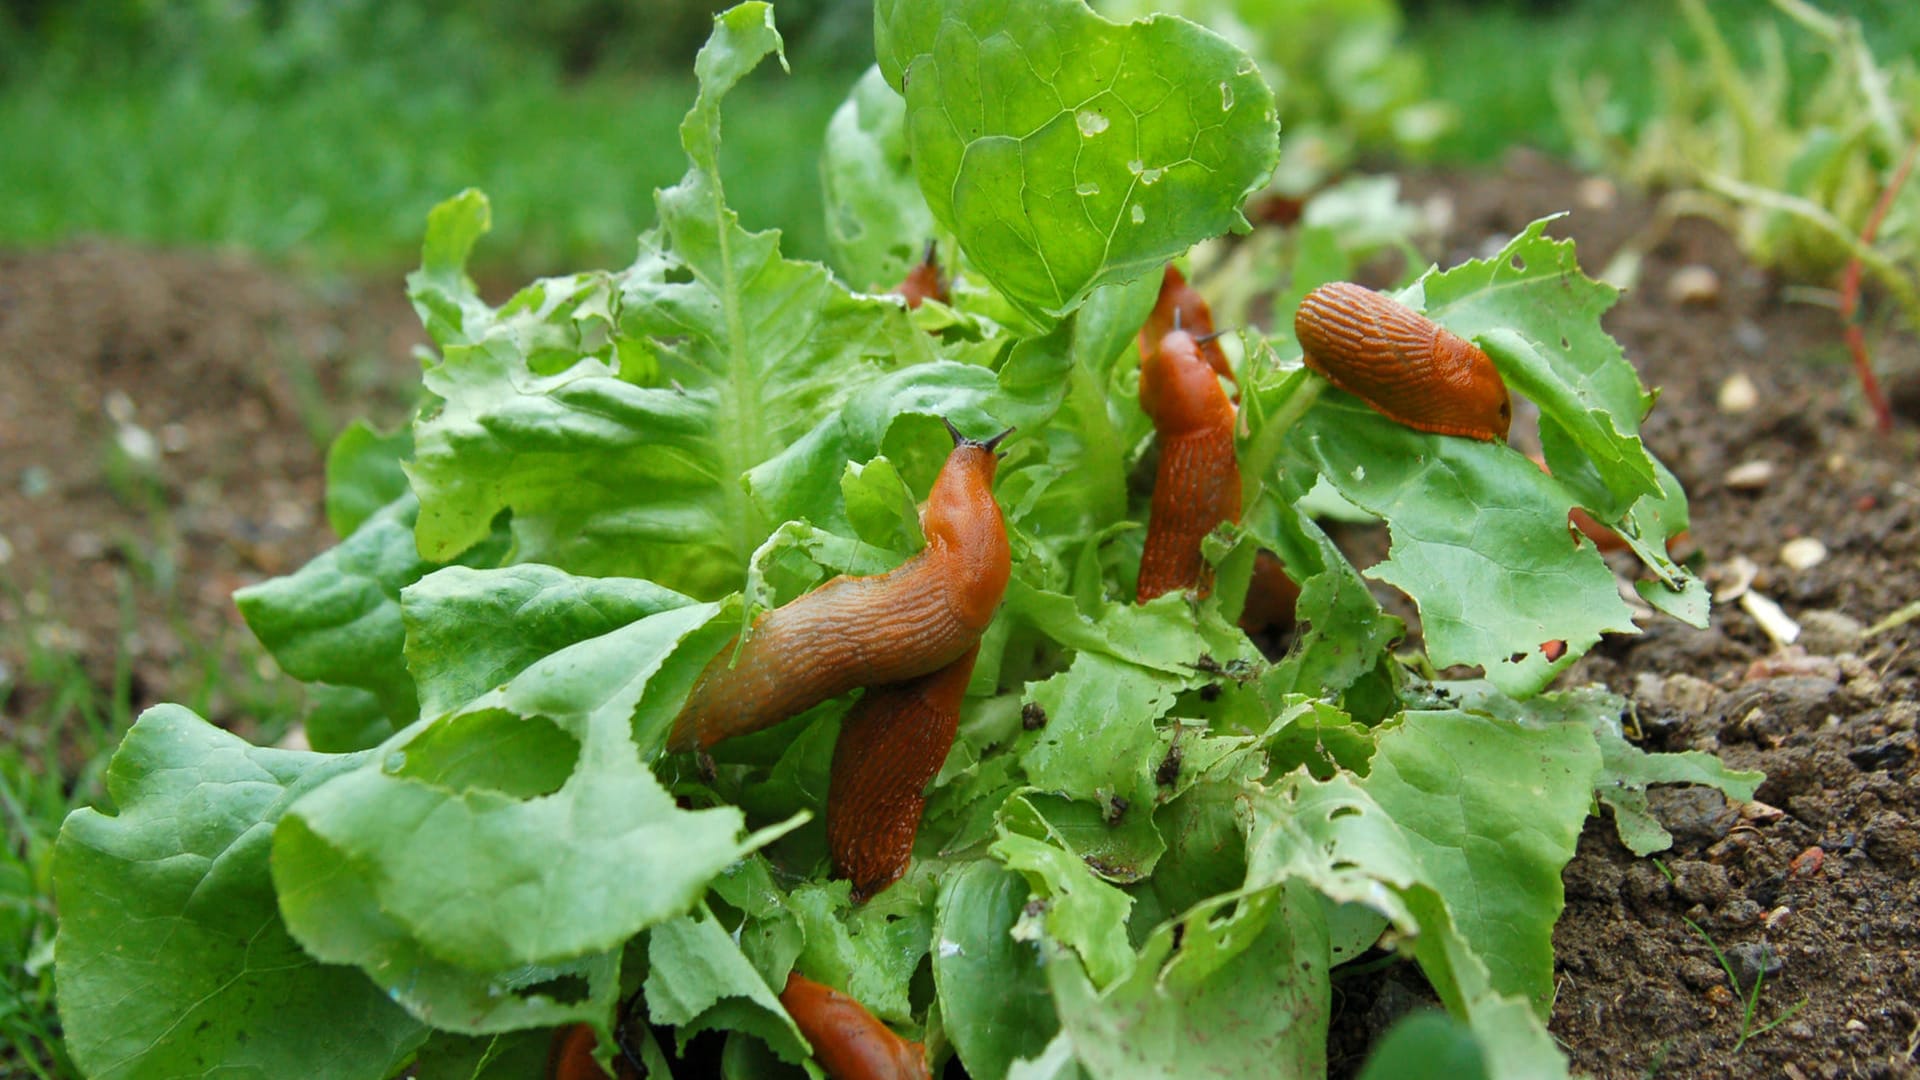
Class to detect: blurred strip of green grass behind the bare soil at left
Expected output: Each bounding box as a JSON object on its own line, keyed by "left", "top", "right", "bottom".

{"left": 0, "top": 73, "right": 854, "bottom": 273}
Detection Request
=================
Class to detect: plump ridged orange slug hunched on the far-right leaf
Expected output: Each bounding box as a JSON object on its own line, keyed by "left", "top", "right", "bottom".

{"left": 1294, "top": 281, "right": 1513, "bottom": 442}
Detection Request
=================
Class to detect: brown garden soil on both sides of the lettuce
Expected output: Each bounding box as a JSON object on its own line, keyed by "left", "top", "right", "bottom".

{"left": 0, "top": 158, "right": 1920, "bottom": 1080}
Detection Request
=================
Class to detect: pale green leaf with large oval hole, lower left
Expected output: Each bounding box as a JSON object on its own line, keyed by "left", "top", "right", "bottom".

{"left": 275, "top": 605, "right": 781, "bottom": 982}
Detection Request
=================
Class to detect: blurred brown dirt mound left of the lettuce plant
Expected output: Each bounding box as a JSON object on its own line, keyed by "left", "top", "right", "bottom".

{"left": 0, "top": 244, "right": 424, "bottom": 738}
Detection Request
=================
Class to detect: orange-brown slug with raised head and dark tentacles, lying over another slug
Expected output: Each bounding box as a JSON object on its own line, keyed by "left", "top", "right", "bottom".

{"left": 666, "top": 423, "right": 1013, "bottom": 751}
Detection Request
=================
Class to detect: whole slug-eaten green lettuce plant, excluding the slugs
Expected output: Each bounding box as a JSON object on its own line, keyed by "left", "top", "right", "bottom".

{"left": 56, "top": 0, "right": 1757, "bottom": 1078}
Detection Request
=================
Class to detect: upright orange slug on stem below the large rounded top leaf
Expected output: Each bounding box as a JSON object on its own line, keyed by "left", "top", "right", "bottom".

{"left": 1137, "top": 329, "right": 1240, "bottom": 601}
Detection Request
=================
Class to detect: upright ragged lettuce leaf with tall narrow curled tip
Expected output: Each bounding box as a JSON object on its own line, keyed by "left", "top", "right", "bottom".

{"left": 407, "top": 4, "right": 956, "bottom": 596}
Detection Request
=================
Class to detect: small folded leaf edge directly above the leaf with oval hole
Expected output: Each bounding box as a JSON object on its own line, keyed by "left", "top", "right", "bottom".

{"left": 399, "top": 565, "right": 693, "bottom": 717}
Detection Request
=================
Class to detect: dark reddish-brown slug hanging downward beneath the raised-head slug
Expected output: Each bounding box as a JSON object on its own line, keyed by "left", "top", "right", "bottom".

{"left": 828, "top": 646, "right": 979, "bottom": 903}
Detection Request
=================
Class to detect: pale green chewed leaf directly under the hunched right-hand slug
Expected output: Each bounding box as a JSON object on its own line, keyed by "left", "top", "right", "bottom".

{"left": 1290, "top": 392, "right": 1638, "bottom": 698}
